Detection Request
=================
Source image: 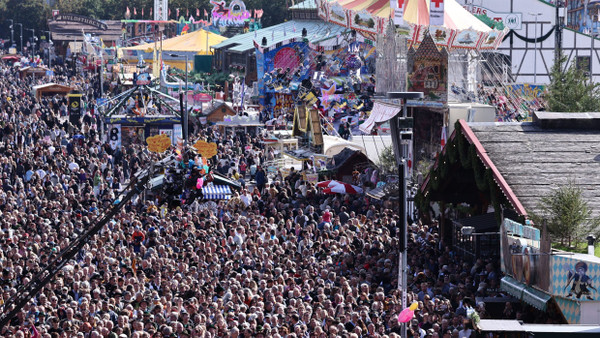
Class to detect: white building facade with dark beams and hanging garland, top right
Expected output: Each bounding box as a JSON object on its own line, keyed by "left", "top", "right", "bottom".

{"left": 457, "top": 0, "right": 600, "bottom": 84}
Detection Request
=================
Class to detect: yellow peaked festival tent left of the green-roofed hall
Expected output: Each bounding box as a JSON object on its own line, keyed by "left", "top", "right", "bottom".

{"left": 119, "top": 29, "right": 227, "bottom": 70}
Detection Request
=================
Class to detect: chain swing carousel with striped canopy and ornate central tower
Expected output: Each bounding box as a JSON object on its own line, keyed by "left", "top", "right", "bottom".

{"left": 317, "top": 0, "right": 539, "bottom": 163}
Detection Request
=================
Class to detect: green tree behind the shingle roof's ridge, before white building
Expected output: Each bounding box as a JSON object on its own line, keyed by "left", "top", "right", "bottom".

{"left": 547, "top": 55, "right": 600, "bottom": 112}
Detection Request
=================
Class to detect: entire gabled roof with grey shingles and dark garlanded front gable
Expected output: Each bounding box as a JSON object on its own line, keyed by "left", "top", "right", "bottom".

{"left": 417, "top": 112, "right": 600, "bottom": 227}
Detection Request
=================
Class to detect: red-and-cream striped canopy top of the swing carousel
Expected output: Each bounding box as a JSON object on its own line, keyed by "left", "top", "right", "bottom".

{"left": 317, "top": 0, "right": 508, "bottom": 49}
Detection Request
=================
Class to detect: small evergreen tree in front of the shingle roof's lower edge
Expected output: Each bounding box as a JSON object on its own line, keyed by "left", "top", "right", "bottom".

{"left": 531, "top": 182, "right": 599, "bottom": 247}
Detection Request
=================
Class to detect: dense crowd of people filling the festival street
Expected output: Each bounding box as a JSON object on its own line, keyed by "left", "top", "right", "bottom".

{"left": 0, "top": 56, "right": 510, "bottom": 338}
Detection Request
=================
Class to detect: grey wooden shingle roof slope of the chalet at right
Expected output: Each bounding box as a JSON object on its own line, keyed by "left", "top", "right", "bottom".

{"left": 468, "top": 113, "right": 600, "bottom": 216}
